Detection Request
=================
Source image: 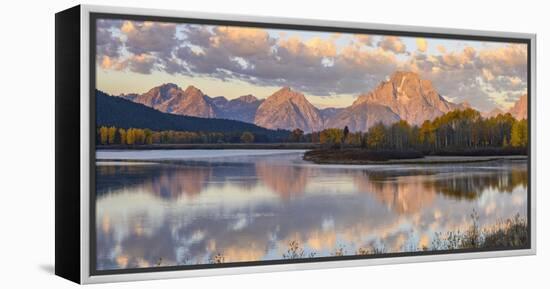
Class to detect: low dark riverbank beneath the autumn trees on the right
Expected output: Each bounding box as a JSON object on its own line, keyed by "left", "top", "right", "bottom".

{"left": 303, "top": 149, "right": 527, "bottom": 165}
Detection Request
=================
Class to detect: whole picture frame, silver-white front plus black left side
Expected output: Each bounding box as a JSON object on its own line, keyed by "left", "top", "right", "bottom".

{"left": 55, "top": 5, "right": 536, "bottom": 284}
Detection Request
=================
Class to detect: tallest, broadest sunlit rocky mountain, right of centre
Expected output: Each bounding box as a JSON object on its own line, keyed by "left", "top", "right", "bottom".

{"left": 352, "top": 71, "right": 467, "bottom": 125}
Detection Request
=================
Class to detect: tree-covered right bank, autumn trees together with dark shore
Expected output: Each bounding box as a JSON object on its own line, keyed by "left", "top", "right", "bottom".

{"left": 304, "top": 109, "right": 529, "bottom": 164}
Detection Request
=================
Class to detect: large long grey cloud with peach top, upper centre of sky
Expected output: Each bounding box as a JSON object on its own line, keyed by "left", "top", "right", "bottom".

{"left": 175, "top": 26, "right": 396, "bottom": 95}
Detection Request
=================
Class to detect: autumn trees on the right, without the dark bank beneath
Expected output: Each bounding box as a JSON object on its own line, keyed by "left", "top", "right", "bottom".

{"left": 319, "top": 109, "right": 529, "bottom": 151}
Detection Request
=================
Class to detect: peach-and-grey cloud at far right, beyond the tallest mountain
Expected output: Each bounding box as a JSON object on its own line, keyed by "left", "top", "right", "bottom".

{"left": 404, "top": 45, "right": 527, "bottom": 110}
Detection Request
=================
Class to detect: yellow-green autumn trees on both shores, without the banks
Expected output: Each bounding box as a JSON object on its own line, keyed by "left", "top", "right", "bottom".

{"left": 97, "top": 109, "right": 529, "bottom": 148}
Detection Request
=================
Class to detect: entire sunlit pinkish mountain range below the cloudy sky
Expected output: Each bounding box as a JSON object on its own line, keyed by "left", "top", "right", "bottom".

{"left": 116, "top": 71, "right": 527, "bottom": 132}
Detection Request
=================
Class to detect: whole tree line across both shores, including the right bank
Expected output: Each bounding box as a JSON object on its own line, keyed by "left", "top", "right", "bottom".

{"left": 96, "top": 109, "right": 529, "bottom": 162}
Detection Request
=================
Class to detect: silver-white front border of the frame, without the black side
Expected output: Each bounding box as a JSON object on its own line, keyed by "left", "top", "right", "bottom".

{"left": 80, "top": 5, "right": 536, "bottom": 284}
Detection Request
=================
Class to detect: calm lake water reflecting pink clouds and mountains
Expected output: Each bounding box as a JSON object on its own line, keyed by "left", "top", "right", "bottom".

{"left": 96, "top": 150, "right": 527, "bottom": 270}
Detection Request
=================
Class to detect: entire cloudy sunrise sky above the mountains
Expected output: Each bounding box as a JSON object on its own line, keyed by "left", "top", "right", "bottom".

{"left": 96, "top": 19, "right": 527, "bottom": 111}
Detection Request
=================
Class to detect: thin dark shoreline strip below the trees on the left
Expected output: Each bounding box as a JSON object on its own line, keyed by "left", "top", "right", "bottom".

{"left": 96, "top": 143, "right": 321, "bottom": 150}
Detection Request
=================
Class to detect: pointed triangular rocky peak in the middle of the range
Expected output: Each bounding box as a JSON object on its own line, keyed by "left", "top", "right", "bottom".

{"left": 254, "top": 87, "right": 323, "bottom": 132}
